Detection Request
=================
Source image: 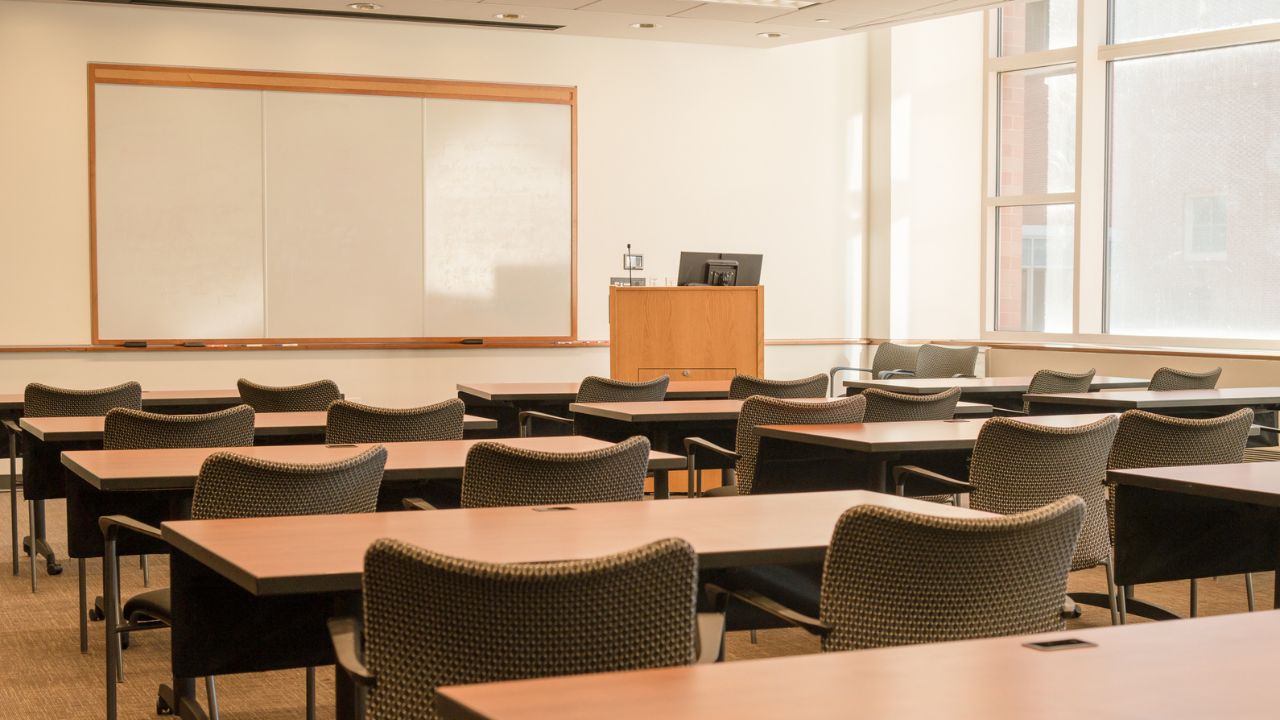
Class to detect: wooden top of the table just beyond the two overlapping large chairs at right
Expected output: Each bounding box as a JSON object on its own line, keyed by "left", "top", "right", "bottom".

{"left": 755, "top": 413, "right": 1114, "bottom": 452}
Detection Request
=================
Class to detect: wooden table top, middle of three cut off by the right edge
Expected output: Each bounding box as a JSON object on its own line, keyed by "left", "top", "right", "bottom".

{"left": 1107, "top": 462, "right": 1280, "bottom": 507}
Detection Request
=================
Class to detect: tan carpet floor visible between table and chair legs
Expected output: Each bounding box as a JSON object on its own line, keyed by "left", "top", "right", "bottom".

{"left": 0, "top": 495, "right": 1272, "bottom": 720}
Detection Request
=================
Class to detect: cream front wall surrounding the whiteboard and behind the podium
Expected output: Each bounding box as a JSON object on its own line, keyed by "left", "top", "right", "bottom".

{"left": 0, "top": 0, "right": 867, "bottom": 404}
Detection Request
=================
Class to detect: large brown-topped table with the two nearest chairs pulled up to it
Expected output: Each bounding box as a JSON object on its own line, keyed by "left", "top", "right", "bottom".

{"left": 161, "top": 491, "right": 989, "bottom": 719}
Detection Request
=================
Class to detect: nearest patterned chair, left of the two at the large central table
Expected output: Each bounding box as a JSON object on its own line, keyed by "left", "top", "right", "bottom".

{"left": 329, "top": 539, "right": 719, "bottom": 720}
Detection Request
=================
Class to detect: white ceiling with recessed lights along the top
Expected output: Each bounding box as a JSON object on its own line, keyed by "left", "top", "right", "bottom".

{"left": 82, "top": 0, "right": 1002, "bottom": 47}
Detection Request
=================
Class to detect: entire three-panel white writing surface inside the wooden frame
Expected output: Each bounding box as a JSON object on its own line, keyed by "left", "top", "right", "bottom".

{"left": 92, "top": 78, "right": 573, "bottom": 342}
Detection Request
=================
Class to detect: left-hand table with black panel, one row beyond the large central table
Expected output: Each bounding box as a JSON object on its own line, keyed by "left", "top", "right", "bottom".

{"left": 61, "top": 437, "right": 685, "bottom": 651}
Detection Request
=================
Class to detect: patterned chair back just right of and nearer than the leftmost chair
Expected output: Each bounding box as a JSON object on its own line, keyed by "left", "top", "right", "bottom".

{"left": 102, "top": 405, "right": 253, "bottom": 450}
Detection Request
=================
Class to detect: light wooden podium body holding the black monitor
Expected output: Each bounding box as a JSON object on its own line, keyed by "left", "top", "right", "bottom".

{"left": 609, "top": 286, "right": 764, "bottom": 382}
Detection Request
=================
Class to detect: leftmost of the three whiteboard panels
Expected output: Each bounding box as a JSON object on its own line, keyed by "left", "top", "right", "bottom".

{"left": 95, "top": 85, "right": 266, "bottom": 340}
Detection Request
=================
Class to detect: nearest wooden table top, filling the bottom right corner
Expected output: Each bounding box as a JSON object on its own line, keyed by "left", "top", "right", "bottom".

{"left": 439, "top": 611, "right": 1280, "bottom": 720}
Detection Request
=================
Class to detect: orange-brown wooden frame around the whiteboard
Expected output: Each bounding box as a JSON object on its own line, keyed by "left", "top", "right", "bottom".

{"left": 88, "top": 63, "right": 577, "bottom": 350}
